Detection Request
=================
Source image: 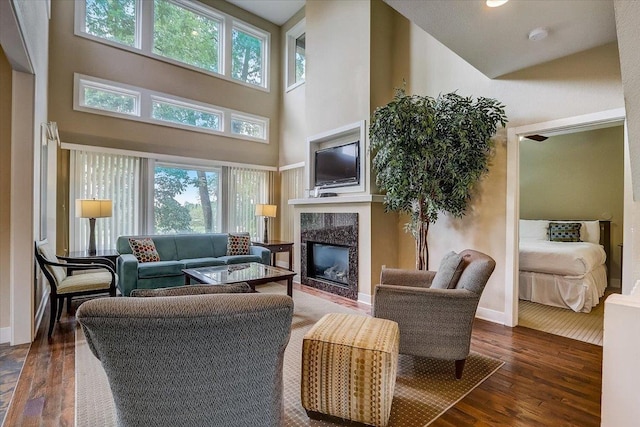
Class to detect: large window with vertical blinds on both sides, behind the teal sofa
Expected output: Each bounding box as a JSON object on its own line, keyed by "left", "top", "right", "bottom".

{"left": 69, "top": 146, "right": 275, "bottom": 251}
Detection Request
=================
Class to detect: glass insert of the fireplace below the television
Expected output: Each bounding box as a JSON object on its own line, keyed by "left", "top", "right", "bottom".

{"left": 307, "top": 242, "right": 349, "bottom": 286}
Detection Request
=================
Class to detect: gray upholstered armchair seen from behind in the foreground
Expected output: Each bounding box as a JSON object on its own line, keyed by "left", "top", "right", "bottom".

{"left": 76, "top": 293, "right": 293, "bottom": 427}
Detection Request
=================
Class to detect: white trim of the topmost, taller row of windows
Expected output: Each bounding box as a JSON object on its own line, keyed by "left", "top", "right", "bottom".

{"left": 74, "top": 0, "right": 271, "bottom": 92}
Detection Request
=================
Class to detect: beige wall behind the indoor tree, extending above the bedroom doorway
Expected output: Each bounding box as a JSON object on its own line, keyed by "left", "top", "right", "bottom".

{"left": 401, "top": 25, "right": 623, "bottom": 313}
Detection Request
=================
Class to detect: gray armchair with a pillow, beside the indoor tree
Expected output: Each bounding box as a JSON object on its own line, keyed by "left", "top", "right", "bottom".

{"left": 373, "top": 249, "right": 496, "bottom": 379}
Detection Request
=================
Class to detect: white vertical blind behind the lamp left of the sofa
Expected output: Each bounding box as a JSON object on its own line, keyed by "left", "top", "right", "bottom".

{"left": 69, "top": 150, "right": 141, "bottom": 252}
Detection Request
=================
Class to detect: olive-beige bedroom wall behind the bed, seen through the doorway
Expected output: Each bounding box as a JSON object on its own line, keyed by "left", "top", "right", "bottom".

{"left": 520, "top": 126, "right": 624, "bottom": 284}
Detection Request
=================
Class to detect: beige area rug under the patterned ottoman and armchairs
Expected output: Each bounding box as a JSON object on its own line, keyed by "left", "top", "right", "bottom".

{"left": 76, "top": 284, "right": 503, "bottom": 427}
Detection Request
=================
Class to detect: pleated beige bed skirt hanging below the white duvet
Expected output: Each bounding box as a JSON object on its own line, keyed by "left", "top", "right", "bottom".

{"left": 519, "top": 265, "right": 607, "bottom": 313}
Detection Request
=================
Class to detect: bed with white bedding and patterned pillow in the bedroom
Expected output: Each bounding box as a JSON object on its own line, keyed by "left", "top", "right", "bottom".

{"left": 519, "top": 220, "right": 609, "bottom": 313}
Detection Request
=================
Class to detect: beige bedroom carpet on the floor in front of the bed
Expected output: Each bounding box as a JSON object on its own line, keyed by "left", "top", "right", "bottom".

{"left": 518, "top": 294, "right": 608, "bottom": 346}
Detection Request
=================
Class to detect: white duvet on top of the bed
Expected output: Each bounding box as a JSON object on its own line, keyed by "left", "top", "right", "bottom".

{"left": 520, "top": 239, "right": 607, "bottom": 276}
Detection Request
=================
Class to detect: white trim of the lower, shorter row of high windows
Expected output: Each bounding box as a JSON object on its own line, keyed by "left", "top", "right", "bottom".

{"left": 73, "top": 73, "right": 269, "bottom": 144}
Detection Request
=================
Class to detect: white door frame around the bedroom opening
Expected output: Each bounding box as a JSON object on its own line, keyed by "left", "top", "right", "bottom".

{"left": 504, "top": 108, "right": 628, "bottom": 327}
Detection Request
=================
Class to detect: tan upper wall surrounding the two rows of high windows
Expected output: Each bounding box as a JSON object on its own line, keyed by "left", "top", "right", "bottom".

{"left": 49, "top": 0, "right": 281, "bottom": 166}
